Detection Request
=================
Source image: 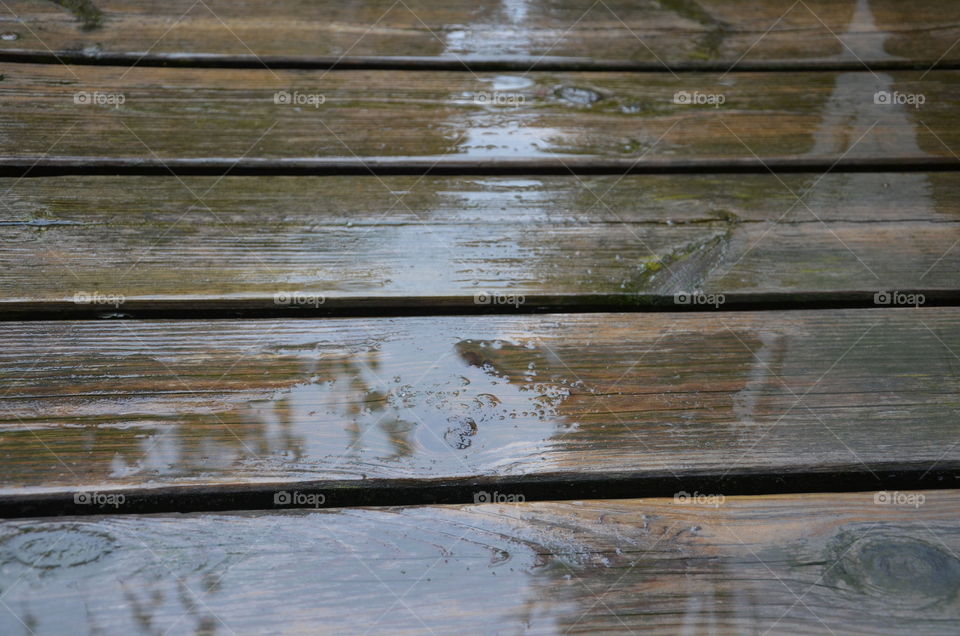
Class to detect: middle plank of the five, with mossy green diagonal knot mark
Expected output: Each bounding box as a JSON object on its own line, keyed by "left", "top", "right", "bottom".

{"left": 0, "top": 173, "right": 960, "bottom": 317}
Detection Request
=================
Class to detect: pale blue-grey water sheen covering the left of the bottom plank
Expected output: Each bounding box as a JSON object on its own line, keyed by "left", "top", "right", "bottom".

{"left": 0, "top": 506, "right": 700, "bottom": 634}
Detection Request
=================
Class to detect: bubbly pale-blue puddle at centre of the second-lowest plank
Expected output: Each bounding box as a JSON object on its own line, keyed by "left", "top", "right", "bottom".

{"left": 240, "top": 330, "right": 571, "bottom": 473}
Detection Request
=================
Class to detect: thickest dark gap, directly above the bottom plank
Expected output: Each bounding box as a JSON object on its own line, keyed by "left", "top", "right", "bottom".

{"left": 0, "top": 462, "right": 960, "bottom": 518}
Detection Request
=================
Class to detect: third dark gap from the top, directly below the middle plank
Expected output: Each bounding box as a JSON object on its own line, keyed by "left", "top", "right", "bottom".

{"left": 0, "top": 294, "right": 960, "bottom": 323}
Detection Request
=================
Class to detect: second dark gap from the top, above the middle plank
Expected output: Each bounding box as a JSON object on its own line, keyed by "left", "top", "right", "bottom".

{"left": 0, "top": 156, "right": 960, "bottom": 177}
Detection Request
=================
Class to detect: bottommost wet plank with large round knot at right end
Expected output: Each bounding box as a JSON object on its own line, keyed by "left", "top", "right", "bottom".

{"left": 0, "top": 490, "right": 960, "bottom": 635}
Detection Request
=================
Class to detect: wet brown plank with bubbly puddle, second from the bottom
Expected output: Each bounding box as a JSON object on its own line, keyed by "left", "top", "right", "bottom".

{"left": 0, "top": 307, "right": 960, "bottom": 501}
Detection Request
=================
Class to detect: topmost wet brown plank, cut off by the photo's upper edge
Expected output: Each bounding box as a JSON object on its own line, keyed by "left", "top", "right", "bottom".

{"left": 0, "top": 0, "right": 960, "bottom": 69}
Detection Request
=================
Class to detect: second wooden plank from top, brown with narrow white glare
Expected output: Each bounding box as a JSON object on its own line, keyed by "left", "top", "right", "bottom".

{"left": 0, "top": 64, "right": 960, "bottom": 169}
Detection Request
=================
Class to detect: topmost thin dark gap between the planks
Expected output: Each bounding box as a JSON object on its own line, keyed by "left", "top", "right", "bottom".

{"left": 0, "top": 50, "right": 960, "bottom": 73}
